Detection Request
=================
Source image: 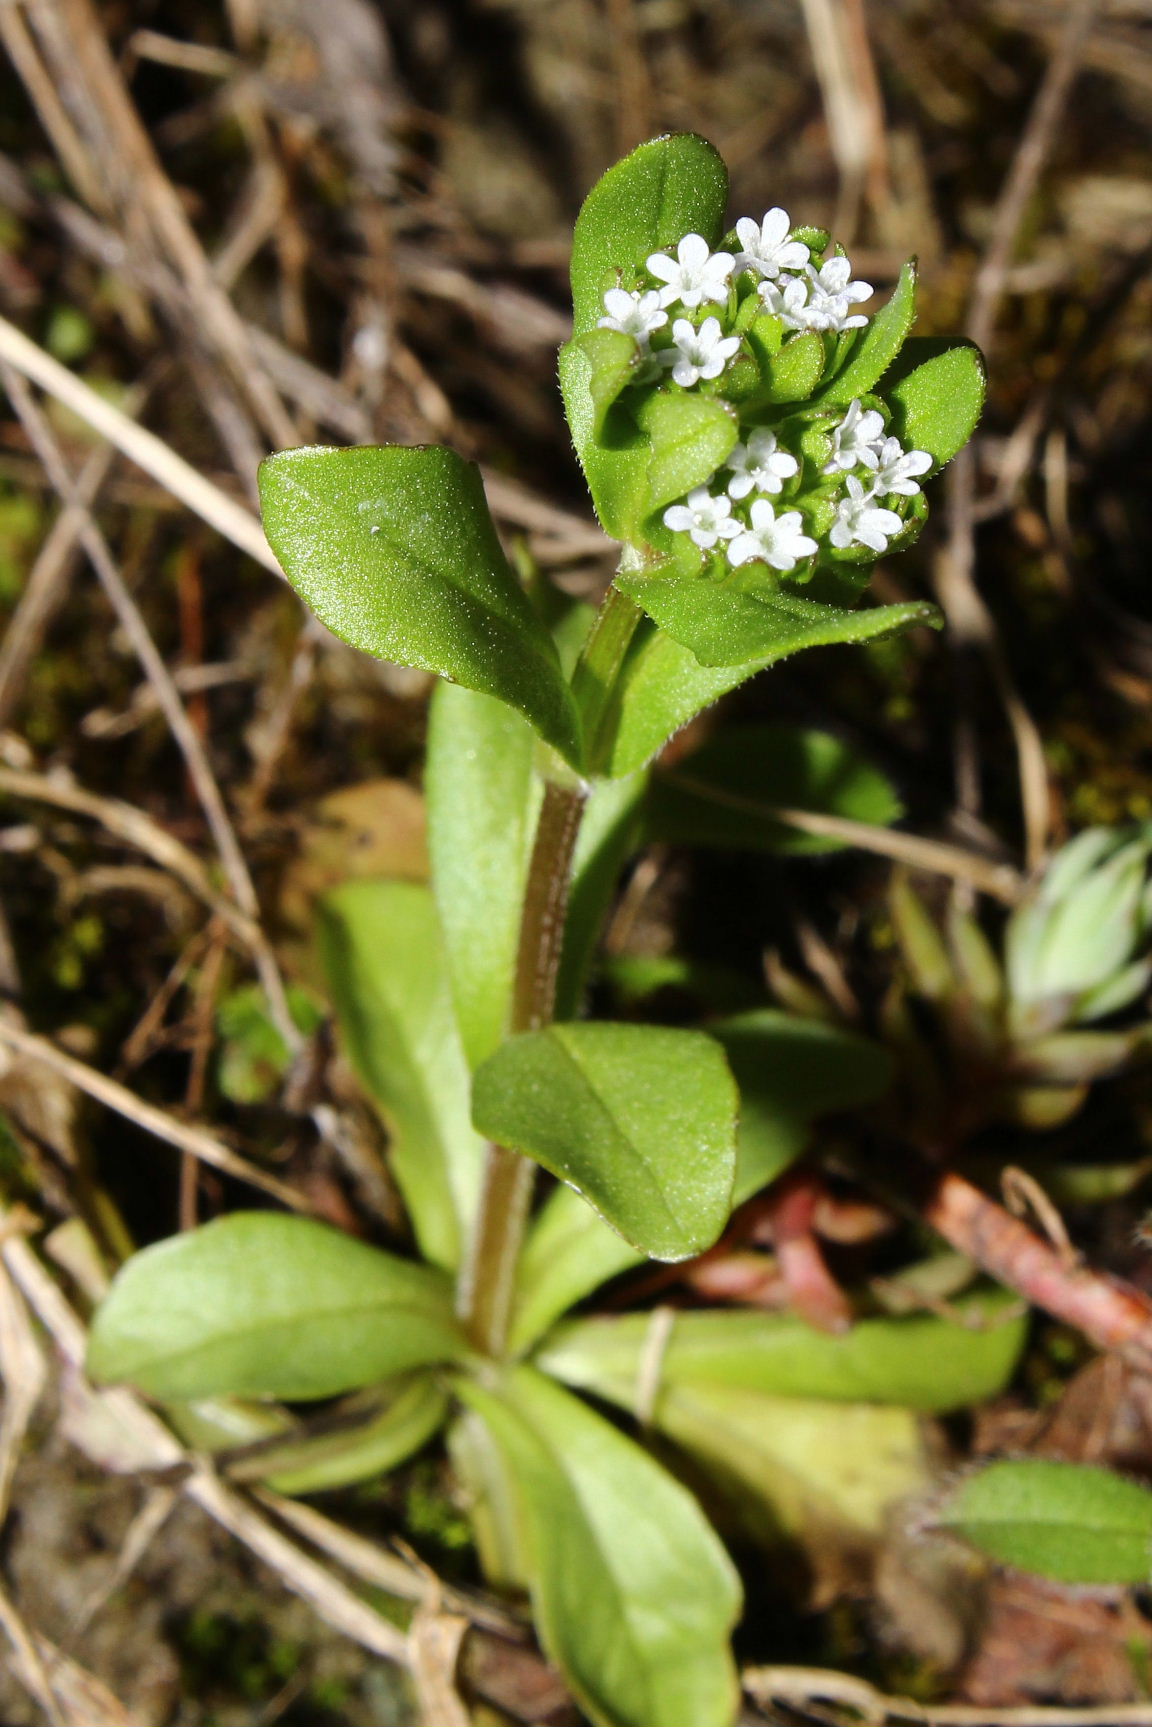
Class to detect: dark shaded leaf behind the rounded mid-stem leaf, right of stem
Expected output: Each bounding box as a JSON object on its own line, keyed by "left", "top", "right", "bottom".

{"left": 710, "top": 1007, "right": 893, "bottom": 1205}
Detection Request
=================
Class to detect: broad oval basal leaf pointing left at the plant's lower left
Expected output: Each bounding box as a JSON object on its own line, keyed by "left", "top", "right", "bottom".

{"left": 88, "top": 1211, "right": 468, "bottom": 1401}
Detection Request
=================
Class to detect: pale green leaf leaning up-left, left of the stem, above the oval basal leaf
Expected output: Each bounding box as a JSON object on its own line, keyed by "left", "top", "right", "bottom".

{"left": 320, "top": 881, "right": 484, "bottom": 1269}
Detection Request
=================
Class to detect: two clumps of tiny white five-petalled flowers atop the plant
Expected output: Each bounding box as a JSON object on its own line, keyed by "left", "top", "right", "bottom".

{"left": 599, "top": 209, "right": 933, "bottom": 573}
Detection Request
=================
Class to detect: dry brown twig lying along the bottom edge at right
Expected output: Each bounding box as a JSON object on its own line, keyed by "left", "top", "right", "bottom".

{"left": 741, "top": 1667, "right": 1152, "bottom": 1727}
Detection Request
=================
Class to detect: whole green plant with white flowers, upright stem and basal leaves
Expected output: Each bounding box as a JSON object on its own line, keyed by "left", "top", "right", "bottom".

{"left": 90, "top": 136, "right": 994, "bottom": 1727}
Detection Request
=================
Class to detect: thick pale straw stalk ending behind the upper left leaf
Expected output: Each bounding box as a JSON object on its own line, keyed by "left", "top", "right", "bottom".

{"left": 0, "top": 318, "right": 283, "bottom": 575}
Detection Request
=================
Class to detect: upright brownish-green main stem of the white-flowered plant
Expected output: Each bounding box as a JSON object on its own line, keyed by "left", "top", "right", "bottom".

{"left": 459, "top": 573, "right": 641, "bottom": 1359}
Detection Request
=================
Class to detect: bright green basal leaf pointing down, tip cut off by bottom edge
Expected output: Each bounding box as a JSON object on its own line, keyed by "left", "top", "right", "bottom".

{"left": 459, "top": 1368, "right": 741, "bottom": 1727}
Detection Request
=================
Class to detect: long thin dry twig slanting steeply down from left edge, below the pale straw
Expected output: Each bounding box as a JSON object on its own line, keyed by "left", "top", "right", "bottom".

{"left": 0, "top": 359, "right": 302, "bottom": 1052}
